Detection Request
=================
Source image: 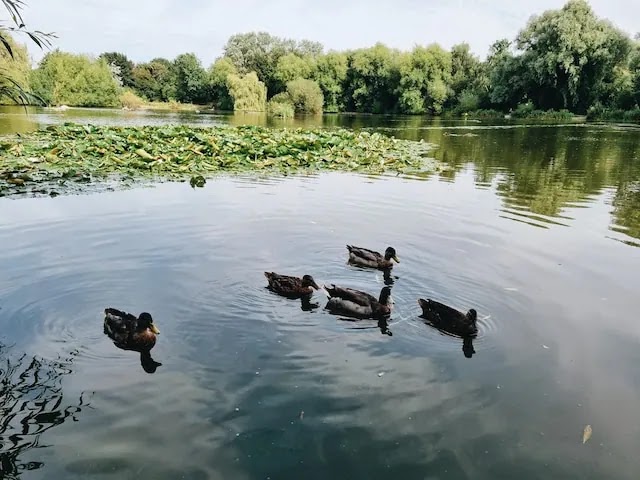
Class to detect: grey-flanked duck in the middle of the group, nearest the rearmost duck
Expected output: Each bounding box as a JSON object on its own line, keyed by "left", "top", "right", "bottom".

{"left": 324, "top": 285, "right": 391, "bottom": 318}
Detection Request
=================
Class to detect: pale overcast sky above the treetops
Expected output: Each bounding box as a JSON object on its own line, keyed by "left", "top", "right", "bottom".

{"left": 17, "top": 0, "right": 640, "bottom": 66}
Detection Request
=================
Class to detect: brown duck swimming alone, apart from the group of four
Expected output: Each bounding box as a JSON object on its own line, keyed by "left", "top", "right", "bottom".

{"left": 104, "top": 308, "right": 160, "bottom": 352}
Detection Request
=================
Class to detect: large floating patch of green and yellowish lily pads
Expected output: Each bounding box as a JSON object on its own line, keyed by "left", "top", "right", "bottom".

{"left": 0, "top": 123, "right": 435, "bottom": 196}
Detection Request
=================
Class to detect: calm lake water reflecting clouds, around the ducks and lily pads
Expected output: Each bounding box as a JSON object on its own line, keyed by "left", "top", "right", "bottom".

{"left": 0, "top": 109, "right": 640, "bottom": 480}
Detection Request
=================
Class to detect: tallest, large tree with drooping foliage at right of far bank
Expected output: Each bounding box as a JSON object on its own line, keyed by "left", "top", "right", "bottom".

{"left": 516, "top": 0, "right": 631, "bottom": 112}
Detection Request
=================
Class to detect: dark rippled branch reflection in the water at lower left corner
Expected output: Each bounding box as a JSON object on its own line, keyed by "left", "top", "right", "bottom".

{"left": 0, "top": 343, "right": 89, "bottom": 479}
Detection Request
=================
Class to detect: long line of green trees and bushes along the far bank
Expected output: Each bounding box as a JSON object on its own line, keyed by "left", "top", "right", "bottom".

{"left": 0, "top": 0, "right": 640, "bottom": 119}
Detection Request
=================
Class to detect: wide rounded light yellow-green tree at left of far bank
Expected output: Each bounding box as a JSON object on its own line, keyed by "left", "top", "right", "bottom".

{"left": 31, "top": 50, "right": 120, "bottom": 107}
